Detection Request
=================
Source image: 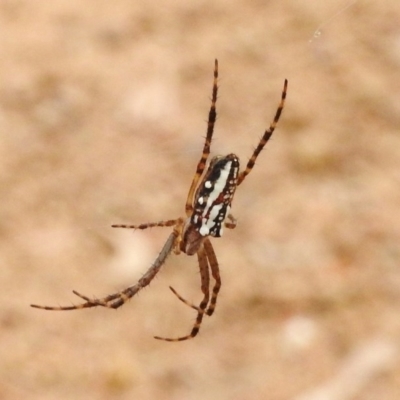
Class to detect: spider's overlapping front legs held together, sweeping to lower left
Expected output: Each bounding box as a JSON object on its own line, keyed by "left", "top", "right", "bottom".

{"left": 31, "top": 230, "right": 177, "bottom": 311}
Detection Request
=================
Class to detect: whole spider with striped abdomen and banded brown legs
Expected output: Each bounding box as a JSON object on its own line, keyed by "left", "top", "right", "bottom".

{"left": 31, "top": 60, "right": 288, "bottom": 342}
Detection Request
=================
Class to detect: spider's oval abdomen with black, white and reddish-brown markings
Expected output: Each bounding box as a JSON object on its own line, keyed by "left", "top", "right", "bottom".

{"left": 191, "top": 154, "right": 239, "bottom": 237}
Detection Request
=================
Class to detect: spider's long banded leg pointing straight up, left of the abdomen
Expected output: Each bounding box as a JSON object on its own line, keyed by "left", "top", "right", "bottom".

{"left": 185, "top": 60, "right": 218, "bottom": 217}
